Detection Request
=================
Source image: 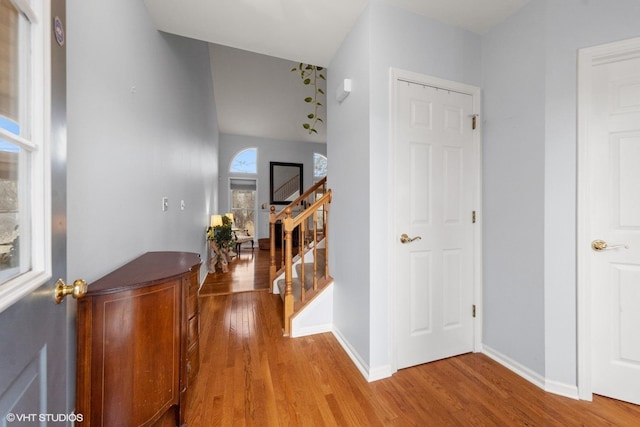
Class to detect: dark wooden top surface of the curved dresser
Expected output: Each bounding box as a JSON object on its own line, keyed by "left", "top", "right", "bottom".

{"left": 86, "top": 252, "right": 202, "bottom": 296}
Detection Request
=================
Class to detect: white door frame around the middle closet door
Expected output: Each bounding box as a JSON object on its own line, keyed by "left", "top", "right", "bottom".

{"left": 389, "top": 67, "right": 483, "bottom": 373}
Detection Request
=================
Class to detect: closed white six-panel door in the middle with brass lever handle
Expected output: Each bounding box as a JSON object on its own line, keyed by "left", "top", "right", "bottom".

{"left": 393, "top": 72, "right": 479, "bottom": 369}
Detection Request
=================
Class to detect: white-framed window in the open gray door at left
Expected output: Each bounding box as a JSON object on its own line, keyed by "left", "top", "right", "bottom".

{"left": 0, "top": 0, "right": 51, "bottom": 311}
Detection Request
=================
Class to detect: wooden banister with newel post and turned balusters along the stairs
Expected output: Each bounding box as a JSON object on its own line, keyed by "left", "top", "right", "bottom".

{"left": 269, "top": 178, "right": 332, "bottom": 335}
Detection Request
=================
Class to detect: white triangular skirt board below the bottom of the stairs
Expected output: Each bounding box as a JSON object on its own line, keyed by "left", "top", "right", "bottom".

{"left": 291, "top": 283, "right": 333, "bottom": 338}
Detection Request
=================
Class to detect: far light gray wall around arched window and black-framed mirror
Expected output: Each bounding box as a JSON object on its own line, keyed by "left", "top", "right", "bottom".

{"left": 215, "top": 134, "right": 331, "bottom": 238}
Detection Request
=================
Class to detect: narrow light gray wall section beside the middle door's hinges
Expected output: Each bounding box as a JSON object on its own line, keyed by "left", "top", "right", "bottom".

{"left": 482, "top": 2, "right": 545, "bottom": 375}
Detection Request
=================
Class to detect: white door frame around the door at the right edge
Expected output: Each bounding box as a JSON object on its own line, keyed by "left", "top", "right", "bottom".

{"left": 576, "top": 37, "right": 640, "bottom": 401}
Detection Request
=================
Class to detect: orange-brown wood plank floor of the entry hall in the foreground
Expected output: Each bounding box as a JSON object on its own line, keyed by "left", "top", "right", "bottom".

{"left": 187, "top": 292, "right": 640, "bottom": 427}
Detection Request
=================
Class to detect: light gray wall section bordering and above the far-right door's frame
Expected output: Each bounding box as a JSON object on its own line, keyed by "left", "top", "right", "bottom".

{"left": 545, "top": 0, "right": 640, "bottom": 384}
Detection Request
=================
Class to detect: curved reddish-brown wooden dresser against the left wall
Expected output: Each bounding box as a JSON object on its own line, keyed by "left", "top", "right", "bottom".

{"left": 76, "top": 252, "right": 201, "bottom": 427}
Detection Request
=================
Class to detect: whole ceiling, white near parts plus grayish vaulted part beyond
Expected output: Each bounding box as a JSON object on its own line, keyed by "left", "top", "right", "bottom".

{"left": 144, "top": 0, "right": 530, "bottom": 142}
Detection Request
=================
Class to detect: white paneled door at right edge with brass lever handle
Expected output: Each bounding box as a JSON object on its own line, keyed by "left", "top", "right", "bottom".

{"left": 582, "top": 39, "right": 640, "bottom": 404}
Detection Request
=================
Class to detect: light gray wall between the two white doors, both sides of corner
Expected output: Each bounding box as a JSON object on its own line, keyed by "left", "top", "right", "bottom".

{"left": 483, "top": 0, "right": 640, "bottom": 386}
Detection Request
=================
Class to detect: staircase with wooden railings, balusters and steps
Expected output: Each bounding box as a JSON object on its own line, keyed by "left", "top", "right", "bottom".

{"left": 269, "top": 178, "right": 333, "bottom": 336}
